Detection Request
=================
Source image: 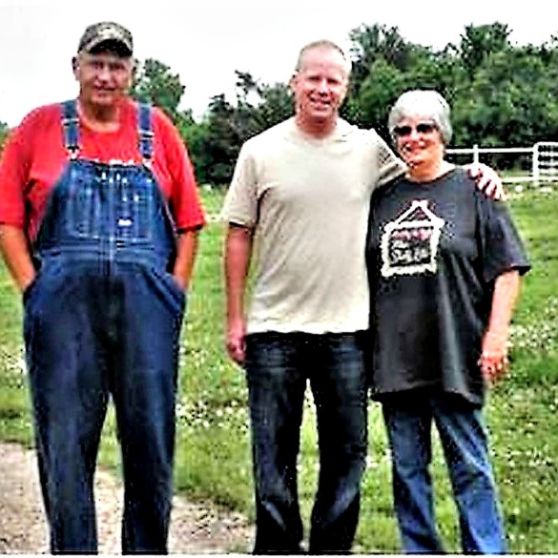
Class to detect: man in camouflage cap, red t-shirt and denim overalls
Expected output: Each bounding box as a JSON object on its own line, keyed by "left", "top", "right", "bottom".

{"left": 0, "top": 18, "right": 204, "bottom": 554}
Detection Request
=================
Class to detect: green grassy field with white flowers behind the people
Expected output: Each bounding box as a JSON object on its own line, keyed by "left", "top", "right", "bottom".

{"left": 0, "top": 186, "right": 558, "bottom": 553}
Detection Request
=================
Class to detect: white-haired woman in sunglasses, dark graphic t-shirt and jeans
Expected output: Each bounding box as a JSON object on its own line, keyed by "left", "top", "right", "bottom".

{"left": 367, "top": 90, "right": 529, "bottom": 553}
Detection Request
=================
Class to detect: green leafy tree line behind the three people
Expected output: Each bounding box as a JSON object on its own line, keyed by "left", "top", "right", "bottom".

{"left": 0, "top": 22, "right": 558, "bottom": 185}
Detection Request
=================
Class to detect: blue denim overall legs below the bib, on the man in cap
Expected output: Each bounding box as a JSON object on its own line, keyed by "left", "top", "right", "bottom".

{"left": 25, "top": 256, "right": 184, "bottom": 554}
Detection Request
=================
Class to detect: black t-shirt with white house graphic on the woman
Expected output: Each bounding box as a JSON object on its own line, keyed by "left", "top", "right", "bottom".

{"left": 367, "top": 169, "right": 529, "bottom": 405}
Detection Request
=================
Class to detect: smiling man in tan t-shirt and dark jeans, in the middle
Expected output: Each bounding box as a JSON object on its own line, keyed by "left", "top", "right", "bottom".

{"left": 223, "top": 41, "right": 504, "bottom": 554}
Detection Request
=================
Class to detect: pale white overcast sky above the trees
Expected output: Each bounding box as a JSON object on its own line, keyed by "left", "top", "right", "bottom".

{"left": 0, "top": 0, "right": 558, "bottom": 126}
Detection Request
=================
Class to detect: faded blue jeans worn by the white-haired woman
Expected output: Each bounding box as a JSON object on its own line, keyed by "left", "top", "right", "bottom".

{"left": 383, "top": 391, "right": 506, "bottom": 554}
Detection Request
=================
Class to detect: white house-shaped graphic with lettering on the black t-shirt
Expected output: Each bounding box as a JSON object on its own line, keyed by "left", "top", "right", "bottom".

{"left": 381, "top": 200, "right": 445, "bottom": 277}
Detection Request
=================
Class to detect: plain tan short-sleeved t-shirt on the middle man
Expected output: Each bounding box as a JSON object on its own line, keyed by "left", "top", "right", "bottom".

{"left": 222, "top": 118, "right": 405, "bottom": 333}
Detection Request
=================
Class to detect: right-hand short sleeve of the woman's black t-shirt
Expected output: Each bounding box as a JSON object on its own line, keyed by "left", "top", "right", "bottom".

{"left": 476, "top": 196, "right": 531, "bottom": 283}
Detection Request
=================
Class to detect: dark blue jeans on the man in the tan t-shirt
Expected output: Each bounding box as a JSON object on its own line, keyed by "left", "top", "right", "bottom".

{"left": 246, "top": 332, "right": 367, "bottom": 554}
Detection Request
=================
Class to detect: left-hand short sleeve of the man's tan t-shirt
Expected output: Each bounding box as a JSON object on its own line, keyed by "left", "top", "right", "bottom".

{"left": 221, "top": 143, "right": 258, "bottom": 228}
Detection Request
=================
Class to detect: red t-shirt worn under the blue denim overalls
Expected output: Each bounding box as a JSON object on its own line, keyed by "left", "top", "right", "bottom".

{"left": 0, "top": 100, "right": 205, "bottom": 239}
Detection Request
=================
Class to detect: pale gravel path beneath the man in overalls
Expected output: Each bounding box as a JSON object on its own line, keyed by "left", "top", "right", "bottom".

{"left": 0, "top": 444, "right": 253, "bottom": 554}
